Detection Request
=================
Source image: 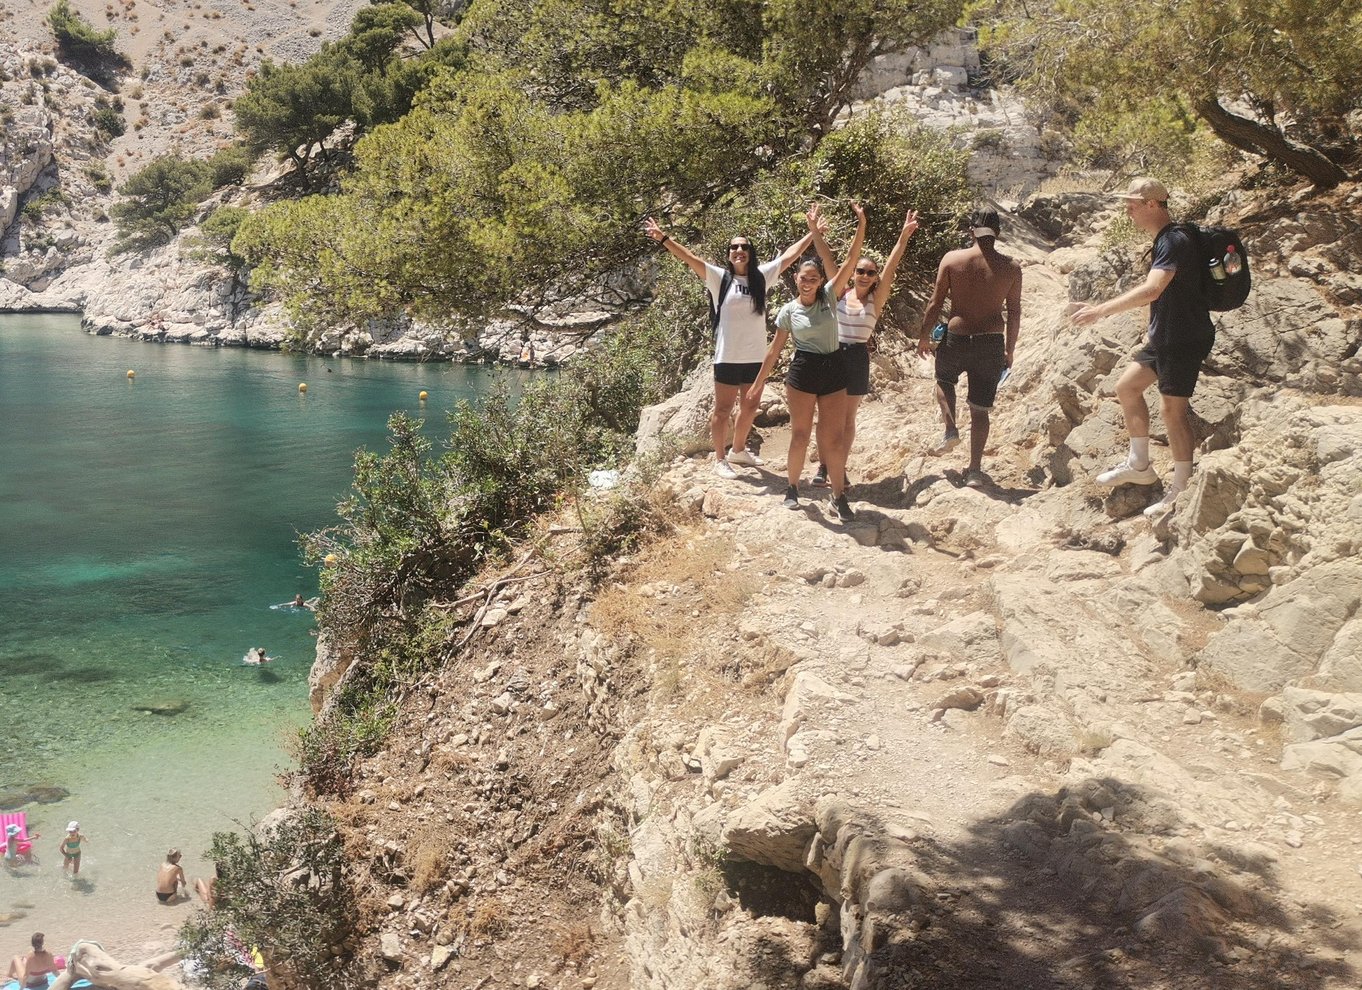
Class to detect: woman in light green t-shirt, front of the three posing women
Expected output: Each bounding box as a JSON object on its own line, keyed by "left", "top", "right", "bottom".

{"left": 748, "top": 203, "right": 865, "bottom": 523}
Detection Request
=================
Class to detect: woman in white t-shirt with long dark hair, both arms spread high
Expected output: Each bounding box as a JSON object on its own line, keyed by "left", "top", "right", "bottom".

{"left": 643, "top": 217, "right": 813, "bottom": 478}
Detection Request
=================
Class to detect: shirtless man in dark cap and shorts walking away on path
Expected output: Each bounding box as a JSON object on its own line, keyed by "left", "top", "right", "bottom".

{"left": 918, "top": 210, "right": 1022, "bottom": 488}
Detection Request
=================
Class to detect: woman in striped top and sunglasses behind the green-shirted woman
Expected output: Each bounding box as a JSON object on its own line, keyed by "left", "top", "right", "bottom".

{"left": 813, "top": 210, "right": 918, "bottom": 486}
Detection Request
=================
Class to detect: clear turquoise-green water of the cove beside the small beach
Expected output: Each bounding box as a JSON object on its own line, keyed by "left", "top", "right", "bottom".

{"left": 0, "top": 316, "right": 501, "bottom": 957}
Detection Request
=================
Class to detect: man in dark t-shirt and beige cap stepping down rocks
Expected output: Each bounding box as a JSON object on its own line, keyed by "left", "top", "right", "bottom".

{"left": 1073, "top": 178, "right": 1215, "bottom": 517}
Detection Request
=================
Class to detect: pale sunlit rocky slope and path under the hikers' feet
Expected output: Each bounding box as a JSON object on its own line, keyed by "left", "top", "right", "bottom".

{"left": 295, "top": 179, "right": 1362, "bottom": 990}
